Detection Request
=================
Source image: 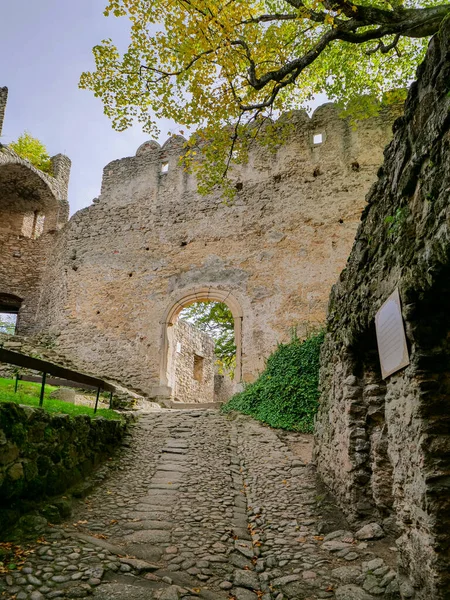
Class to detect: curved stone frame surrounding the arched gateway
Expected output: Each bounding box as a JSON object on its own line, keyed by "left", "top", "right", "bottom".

{"left": 155, "top": 287, "right": 244, "bottom": 395}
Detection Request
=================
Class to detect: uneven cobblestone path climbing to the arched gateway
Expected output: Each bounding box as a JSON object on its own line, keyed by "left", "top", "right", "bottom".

{"left": 0, "top": 410, "right": 400, "bottom": 600}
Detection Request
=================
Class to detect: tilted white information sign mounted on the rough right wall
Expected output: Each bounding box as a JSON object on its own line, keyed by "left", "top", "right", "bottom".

{"left": 375, "top": 289, "right": 409, "bottom": 379}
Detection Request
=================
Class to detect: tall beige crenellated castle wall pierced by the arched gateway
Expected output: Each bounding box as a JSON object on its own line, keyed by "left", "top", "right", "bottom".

{"left": 30, "top": 104, "right": 396, "bottom": 396}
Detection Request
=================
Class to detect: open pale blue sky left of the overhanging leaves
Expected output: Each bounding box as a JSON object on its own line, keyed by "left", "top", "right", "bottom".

{"left": 0, "top": 0, "right": 174, "bottom": 214}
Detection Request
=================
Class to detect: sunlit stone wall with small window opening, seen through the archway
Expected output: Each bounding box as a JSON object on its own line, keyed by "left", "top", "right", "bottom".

{"left": 168, "top": 319, "right": 216, "bottom": 403}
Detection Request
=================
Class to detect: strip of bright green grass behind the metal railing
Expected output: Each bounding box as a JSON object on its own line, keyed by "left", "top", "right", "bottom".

{"left": 0, "top": 379, "right": 121, "bottom": 419}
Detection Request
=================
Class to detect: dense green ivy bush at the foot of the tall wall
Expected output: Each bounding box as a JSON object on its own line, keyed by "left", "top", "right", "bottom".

{"left": 222, "top": 332, "right": 324, "bottom": 433}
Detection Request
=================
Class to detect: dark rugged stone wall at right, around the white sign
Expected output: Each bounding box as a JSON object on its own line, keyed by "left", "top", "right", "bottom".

{"left": 315, "top": 19, "right": 450, "bottom": 600}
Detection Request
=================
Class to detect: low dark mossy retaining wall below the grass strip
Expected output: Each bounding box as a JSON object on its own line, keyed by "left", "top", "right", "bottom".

{"left": 0, "top": 403, "right": 126, "bottom": 529}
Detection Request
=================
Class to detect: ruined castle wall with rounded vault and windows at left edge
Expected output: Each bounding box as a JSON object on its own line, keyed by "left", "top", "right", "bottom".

{"left": 0, "top": 109, "right": 71, "bottom": 334}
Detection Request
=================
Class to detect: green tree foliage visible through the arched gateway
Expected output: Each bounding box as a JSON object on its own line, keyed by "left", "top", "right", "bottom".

{"left": 180, "top": 301, "right": 236, "bottom": 376}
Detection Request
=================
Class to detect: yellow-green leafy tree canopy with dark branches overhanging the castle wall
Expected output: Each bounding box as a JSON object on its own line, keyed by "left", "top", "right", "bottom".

{"left": 80, "top": 0, "right": 450, "bottom": 191}
